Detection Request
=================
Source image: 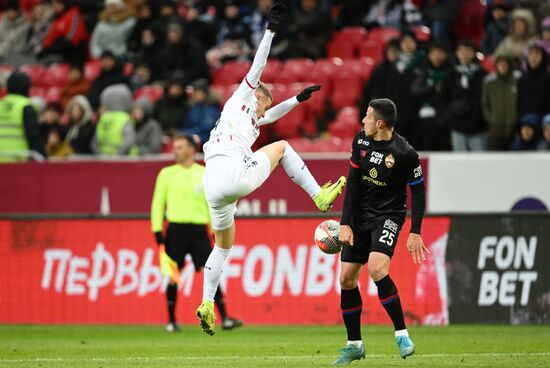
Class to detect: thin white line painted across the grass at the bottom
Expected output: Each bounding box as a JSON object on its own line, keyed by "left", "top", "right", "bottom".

{"left": 0, "top": 352, "right": 550, "bottom": 363}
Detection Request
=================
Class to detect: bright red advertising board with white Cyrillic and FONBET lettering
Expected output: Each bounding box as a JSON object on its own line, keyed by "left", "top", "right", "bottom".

{"left": 0, "top": 218, "right": 449, "bottom": 325}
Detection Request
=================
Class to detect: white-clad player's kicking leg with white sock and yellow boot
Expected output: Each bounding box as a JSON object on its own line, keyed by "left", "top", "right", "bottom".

{"left": 260, "top": 140, "right": 346, "bottom": 212}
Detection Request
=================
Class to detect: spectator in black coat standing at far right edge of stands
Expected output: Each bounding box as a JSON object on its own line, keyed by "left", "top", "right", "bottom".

{"left": 518, "top": 41, "right": 550, "bottom": 118}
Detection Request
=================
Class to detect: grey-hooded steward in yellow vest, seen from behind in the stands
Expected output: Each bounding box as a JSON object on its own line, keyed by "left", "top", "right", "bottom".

{"left": 92, "top": 84, "right": 138, "bottom": 156}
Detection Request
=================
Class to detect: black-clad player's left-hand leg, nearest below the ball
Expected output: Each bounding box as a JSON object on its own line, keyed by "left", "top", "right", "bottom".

{"left": 332, "top": 262, "right": 367, "bottom": 365}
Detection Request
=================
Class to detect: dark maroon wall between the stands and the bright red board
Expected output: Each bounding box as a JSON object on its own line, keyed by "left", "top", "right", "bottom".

{"left": 0, "top": 160, "right": 427, "bottom": 215}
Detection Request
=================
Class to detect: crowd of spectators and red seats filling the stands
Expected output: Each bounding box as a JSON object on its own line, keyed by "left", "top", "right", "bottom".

{"left": 0, "top": 0, "right": 550, "bottom": 161}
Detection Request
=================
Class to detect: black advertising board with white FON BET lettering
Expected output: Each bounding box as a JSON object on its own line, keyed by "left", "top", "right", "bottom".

{"left": 447, "top": 216, "right": 550, "bottom": 324}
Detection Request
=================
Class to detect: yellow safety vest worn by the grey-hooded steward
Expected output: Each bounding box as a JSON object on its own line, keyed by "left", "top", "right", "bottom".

{"left": 96, "top": 111, "right": 138, "bottom": 155}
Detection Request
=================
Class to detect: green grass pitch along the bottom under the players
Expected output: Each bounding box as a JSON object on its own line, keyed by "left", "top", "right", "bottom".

{"left": 0, "top": 325, "right": 550, "bottom": 368}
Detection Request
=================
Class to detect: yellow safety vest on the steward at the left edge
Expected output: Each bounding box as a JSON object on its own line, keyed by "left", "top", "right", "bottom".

{"left": 0, "top": 94, "right": 31, "bottom": 162}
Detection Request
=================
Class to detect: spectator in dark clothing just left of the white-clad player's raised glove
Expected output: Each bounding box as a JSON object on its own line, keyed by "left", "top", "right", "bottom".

{"left": 206, "top": 0, "right": 252, "bottom": 67}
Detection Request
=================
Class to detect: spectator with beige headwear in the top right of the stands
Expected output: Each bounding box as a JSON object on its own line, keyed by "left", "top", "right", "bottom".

{"left": 495, "top": 9, "right": 535, "bottom": 62}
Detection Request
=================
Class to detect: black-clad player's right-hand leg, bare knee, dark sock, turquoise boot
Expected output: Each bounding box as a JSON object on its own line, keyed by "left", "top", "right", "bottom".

{"left": 368, "top": 252, "right": 414, "bottom": 359}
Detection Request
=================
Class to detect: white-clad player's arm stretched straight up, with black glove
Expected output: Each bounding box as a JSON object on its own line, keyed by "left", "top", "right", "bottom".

{"left": 243, "top": 2, "right": 287, "bottom": 88}
